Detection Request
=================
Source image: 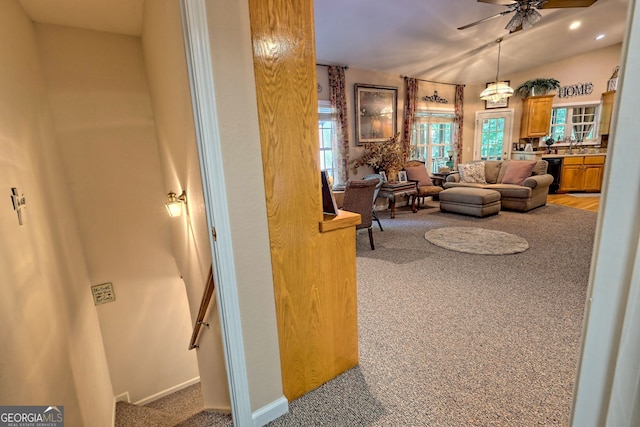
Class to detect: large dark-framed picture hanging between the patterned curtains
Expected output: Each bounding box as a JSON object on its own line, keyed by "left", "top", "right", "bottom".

{"left": 354, "top": 83, "right": 398, "bottom": 145}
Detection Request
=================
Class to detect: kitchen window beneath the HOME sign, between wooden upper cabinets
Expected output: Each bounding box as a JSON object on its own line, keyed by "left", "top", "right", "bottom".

{"left": 549, "top": 104, "right": 598, "bottom": 142}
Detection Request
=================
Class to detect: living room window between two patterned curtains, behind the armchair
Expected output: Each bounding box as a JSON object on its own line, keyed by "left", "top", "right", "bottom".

{"left": 411, "top": 111, "right": 455, "bottom": 173}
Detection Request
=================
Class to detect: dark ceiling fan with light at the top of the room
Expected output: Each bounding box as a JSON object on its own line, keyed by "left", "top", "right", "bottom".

{"left": 458, "top": 0, "right": 597, "bottom": 33}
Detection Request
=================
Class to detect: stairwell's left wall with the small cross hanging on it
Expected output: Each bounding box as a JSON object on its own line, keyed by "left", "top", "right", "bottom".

{"left": 0, "top": 1, "right": 113, "bottom": 426}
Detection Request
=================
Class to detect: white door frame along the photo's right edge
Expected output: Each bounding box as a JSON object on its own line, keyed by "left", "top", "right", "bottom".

{"left": 570, "top": 0, "right": 640, "bottom": 427}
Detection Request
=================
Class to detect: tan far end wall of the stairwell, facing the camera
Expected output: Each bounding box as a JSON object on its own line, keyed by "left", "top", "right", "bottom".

{"left": 36, "top": 24, "right": 198, "bottom": 402}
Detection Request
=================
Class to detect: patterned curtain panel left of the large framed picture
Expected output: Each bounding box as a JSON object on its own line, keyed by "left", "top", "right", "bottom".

{"left": 328, "top": 65, "right": 349, "bottom": 185}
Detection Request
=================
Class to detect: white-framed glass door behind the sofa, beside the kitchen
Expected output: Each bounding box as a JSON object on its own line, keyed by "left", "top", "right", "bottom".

{"left": 473, "top": 109, "right": 513, "bottom": 160}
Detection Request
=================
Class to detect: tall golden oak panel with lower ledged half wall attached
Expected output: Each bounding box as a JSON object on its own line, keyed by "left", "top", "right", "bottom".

{"left": 249, "top": 0, "right": 359, "bottom": 400}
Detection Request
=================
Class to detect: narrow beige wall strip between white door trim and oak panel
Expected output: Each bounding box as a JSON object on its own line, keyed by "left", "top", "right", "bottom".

{"left": 206, "top": 0, "right": 283, "bottom": 412}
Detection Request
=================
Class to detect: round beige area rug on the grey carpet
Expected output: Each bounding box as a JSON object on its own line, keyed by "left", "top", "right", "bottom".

{"left": 424, "top": 227, "right": 529, "bottom": 255}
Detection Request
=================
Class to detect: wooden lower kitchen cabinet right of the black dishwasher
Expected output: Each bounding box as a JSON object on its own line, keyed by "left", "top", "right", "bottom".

{"left": 558, "top": 156, "right": 605, "bottom": 193}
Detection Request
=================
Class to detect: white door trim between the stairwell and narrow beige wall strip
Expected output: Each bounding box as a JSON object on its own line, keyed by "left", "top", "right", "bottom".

{"left": 180, "top": 0, "right": 254, "bottom": 426}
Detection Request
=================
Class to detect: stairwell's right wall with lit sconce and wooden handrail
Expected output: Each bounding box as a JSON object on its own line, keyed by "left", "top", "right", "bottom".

{"left": 142, "top": 0, "right": 230, "bottom": 410}
